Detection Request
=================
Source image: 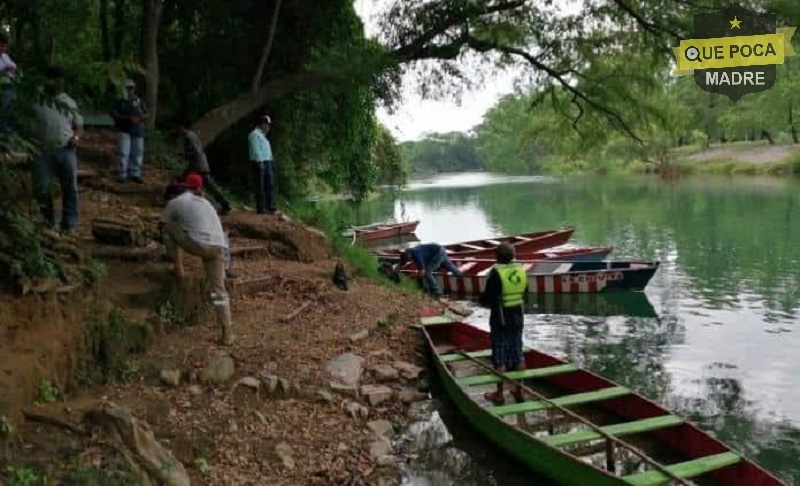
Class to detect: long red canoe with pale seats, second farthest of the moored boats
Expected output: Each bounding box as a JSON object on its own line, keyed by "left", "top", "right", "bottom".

{"left": 375, "top": 228, "right": 575, "bottom": 258}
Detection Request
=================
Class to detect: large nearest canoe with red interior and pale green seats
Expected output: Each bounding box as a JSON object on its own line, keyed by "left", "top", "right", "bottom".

{"left": 422, "top": 313, "right": 784, "bottom": 486}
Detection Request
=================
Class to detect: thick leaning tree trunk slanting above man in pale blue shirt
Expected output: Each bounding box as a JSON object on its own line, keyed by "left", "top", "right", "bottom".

{"left": 192, "top": 73, "right": 332, "bottom": 146}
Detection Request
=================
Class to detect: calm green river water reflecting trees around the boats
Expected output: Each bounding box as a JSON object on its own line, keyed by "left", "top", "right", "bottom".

{"left": 348, "top": 174, "right": 800, "bottom": 484}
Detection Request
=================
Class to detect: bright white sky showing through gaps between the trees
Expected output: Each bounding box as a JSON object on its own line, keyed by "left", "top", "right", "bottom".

{"left": 355, "top": 0, "right": 513, "bottom": 142}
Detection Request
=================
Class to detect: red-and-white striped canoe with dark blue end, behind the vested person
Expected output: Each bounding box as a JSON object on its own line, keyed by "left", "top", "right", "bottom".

{"left": 399, "top": 259, "right": 661, "bottom": 295}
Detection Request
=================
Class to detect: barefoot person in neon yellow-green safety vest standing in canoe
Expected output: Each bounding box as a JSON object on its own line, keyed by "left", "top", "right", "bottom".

{"left": 480, "top": 244, "right": 528, "bottom": 405}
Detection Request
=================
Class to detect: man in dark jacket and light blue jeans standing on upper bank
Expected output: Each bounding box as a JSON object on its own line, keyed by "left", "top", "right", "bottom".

{"left": 111, "top": 79, "right": 147, "bottom": 184}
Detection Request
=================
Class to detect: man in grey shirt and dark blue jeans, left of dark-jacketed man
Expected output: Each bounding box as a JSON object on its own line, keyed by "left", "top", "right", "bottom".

{"left": 33, "top": 68, "right": 83, "bottom": 232}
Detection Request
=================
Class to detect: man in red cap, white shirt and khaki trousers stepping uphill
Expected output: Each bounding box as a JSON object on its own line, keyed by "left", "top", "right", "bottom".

{"left": 161, "top": 173, "right": 233, "bottom": 345}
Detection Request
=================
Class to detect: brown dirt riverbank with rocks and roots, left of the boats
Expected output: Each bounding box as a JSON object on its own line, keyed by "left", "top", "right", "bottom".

{"left": 0, "top": 133, "right": 440, "bottom": 485}
